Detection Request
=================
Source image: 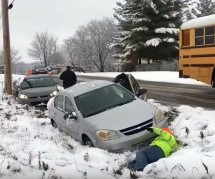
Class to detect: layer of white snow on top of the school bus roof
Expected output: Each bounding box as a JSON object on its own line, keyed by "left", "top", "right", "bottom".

{"left": 181, "top": 14, "right": 215, "bottom": 30}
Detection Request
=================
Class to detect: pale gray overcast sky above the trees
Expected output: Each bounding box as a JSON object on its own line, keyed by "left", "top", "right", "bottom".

{"left": 0, "top": 0, "right": 120, "bottom": 61}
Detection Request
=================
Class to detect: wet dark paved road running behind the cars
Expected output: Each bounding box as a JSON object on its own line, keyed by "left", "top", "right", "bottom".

{"left": 54, "top": 75, "right": 215, "bottom": 110}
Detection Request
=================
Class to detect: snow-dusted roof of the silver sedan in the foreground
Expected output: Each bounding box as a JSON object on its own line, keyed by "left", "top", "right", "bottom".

{"left": 63, "top": 80, "right": 115, "bottom": 97}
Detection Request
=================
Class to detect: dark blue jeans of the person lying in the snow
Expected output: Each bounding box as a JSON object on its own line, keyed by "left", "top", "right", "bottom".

{"left": 128, "top": 145, "right": 165, "bottom": 171}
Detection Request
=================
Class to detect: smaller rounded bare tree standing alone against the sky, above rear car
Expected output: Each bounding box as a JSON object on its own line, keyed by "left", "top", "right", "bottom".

{"left": 28, "top": 32, "right": 57, "bottom": 67}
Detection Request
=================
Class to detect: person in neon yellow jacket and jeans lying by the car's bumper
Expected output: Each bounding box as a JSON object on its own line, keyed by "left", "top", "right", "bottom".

{"left": 128, "top": 128, "right": 177, "bottom": 171}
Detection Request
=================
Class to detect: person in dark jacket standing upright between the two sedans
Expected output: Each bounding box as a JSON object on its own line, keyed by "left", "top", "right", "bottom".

{"left": 60, "top": 66, "right": 77, "bottom": 89}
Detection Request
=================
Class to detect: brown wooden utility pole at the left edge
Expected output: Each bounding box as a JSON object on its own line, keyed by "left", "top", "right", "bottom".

{"left": 2, "top": 0, "right": 12, "bottom": 95}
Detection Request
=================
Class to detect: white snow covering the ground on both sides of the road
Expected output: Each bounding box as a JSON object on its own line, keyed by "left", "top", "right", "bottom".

{"left": 0, "top": 72, "right": 215, "bottom": 179}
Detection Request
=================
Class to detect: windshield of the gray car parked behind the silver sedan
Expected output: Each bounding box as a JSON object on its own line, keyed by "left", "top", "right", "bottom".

{"left": 21, "top": 77, "right": 55, "bottom": 89}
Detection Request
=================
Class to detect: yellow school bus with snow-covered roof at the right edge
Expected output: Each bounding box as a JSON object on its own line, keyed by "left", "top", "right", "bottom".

{"left": 179, "top": 14, "right": 215, "bottom": 87}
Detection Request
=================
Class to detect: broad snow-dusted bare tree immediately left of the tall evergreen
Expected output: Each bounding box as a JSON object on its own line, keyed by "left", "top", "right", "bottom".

{"left": 64, "top": 18, "right": 116, "bottom": 72}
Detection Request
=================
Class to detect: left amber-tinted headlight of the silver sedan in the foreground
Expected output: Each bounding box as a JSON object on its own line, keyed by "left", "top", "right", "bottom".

{"left": 96, "top": 129, "right": 119, "bottom": 140}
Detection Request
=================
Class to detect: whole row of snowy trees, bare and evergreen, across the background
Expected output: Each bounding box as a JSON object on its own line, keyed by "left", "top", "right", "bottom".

{"left": 0, "top": 0, "right": 215, "bottom": 72}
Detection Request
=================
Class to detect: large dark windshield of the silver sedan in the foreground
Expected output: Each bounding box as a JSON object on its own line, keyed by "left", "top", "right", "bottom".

{"left": 75, "top": 84, "right": 135, "bottom": 117}
